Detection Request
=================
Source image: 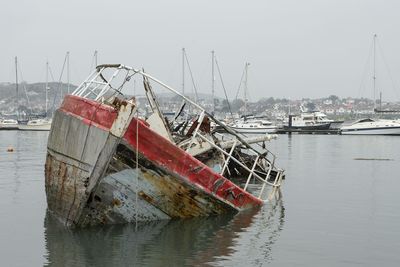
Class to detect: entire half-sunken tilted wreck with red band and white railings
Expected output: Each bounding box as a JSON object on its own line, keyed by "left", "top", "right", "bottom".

{"left": 45, "top": 64, "right": 284, "bottom": 226}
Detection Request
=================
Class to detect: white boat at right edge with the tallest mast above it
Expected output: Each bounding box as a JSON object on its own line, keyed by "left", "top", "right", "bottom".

{"left": 340, "top": 34, "right": 400, "bottom": 135}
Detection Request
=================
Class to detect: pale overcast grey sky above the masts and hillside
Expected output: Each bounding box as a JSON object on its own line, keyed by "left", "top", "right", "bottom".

{"left": 0, "top": 0, "right": 400, "bottom": 100}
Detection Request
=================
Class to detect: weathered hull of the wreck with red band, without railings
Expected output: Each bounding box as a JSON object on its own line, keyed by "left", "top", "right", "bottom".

{"left": 45, "top": 96, "right": 262, "bottom": 226}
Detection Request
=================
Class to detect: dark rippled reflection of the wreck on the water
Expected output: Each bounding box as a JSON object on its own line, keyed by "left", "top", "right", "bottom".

{"left": 44, "top": 200, "right": 284, "bottom": 266}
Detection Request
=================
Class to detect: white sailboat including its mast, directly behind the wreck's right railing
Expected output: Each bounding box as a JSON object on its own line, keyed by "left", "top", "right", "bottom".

{"left": 229, "top": 62, "right": 278, "bottom": 134}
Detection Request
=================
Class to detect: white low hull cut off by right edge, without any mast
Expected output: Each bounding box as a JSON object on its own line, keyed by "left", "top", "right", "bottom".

{"left": 340, "top": 118, "right": 400, "bottom": 135}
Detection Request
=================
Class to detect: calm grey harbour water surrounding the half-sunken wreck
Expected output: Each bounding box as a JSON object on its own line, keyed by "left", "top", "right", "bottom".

{"left": 0, "top": 131, "right": 400, "bottom": 266}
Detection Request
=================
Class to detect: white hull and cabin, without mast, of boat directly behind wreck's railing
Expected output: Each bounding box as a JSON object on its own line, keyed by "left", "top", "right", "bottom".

{"left": 229, "top": 117, "right": 278, "bottom": 134}
